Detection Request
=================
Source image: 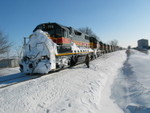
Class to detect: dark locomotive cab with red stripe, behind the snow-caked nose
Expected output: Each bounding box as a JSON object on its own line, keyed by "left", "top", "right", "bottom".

{"left": 33, "top": 23, "right": 71, "bottom": 53}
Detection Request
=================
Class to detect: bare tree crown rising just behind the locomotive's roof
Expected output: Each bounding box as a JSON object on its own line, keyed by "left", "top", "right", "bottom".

{"left": 78, "top": 27, "right": 99, "bottom": 39}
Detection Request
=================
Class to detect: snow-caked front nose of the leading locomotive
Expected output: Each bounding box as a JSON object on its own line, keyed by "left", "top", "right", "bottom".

{"left": 20, "top": 30, "right": 57, "bottom": 73}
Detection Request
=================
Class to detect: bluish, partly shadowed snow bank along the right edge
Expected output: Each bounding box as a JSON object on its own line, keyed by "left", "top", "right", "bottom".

{"left": 112, "top": 50, "right": 150, "bottom": 113}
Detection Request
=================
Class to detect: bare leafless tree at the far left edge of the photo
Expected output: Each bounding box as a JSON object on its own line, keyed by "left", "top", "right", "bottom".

{"left": 0, "top": 31, "right": 11, "bottom": 54}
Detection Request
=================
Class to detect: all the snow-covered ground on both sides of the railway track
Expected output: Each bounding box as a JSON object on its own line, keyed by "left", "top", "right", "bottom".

{"left": 0, "top": 50, "right": 150, "bottom": 113}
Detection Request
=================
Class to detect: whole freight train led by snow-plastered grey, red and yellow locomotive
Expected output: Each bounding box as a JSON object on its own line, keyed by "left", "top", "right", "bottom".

{"left": 20, "top": 23, "right": 120, "bottom": 74}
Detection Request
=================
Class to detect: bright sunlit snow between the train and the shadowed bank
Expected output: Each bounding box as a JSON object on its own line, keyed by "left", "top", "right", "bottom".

{"left": 0, "top": 51, "right": 126, "bottom": 113}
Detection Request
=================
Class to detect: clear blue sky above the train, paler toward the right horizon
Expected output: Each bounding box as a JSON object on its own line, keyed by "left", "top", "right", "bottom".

{"left": 0, "top": 0, "right": 150, "bottom": 47}
